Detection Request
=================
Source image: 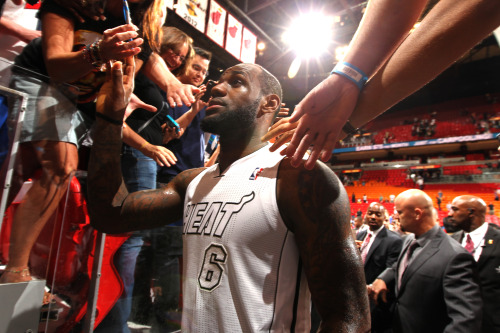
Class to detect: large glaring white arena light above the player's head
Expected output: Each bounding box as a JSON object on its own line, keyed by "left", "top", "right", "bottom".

{"left": 283, "top": 12, "right": 334, "bottom": 59}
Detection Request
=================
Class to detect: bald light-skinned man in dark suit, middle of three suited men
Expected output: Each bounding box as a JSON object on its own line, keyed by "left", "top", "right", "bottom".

{"left": 368, "top": 190, "right": 482, "bottom": 333}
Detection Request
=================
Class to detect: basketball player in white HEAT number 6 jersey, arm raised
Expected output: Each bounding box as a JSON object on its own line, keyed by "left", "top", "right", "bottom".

{"left": 89, "top": 60, "right": 370, "bottom": 332}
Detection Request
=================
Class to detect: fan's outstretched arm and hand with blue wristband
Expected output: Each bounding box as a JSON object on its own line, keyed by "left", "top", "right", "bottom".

{"left": 276, "top": 0, "right": 427, "bottom": 169}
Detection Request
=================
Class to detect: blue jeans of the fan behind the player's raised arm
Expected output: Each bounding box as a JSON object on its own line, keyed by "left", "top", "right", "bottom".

{"left": 94, "top": 146, "right": 156, "bottom": 333}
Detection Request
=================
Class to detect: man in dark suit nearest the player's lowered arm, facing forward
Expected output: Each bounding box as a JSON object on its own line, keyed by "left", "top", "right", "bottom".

{"left": 356, "top": 202, "right": 403, "bottom": 333}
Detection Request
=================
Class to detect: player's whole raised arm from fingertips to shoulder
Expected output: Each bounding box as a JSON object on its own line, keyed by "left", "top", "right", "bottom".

{"left": 88, "top": 57, "right": 200, "bottom": 233}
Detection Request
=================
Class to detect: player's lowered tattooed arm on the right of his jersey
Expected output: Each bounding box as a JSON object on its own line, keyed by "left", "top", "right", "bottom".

{"left": 288, "top": 163, "right": 369, "bottom": 331}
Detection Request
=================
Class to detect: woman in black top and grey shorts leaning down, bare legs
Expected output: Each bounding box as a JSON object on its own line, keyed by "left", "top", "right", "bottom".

{"left": 0, "top": 0, "right": 196, "bottom": 283}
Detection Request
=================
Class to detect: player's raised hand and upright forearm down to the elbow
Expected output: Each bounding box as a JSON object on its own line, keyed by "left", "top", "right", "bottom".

{"left": 88, "top": 57, "right": 135, "bottom": 232}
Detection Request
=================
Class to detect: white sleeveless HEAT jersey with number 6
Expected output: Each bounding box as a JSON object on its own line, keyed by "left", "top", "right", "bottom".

{"left": 182, "top": 146, "right": 311, "bottom": 333}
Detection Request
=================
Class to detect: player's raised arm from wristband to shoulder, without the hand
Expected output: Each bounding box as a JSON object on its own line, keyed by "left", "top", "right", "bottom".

{"left": 88, "top": 115, "right": 203, "bottom": 233}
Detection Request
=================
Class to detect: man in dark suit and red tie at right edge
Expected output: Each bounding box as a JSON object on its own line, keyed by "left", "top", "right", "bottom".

{"left": 448, "top": 195, "right": 500, "bottom": 333}
